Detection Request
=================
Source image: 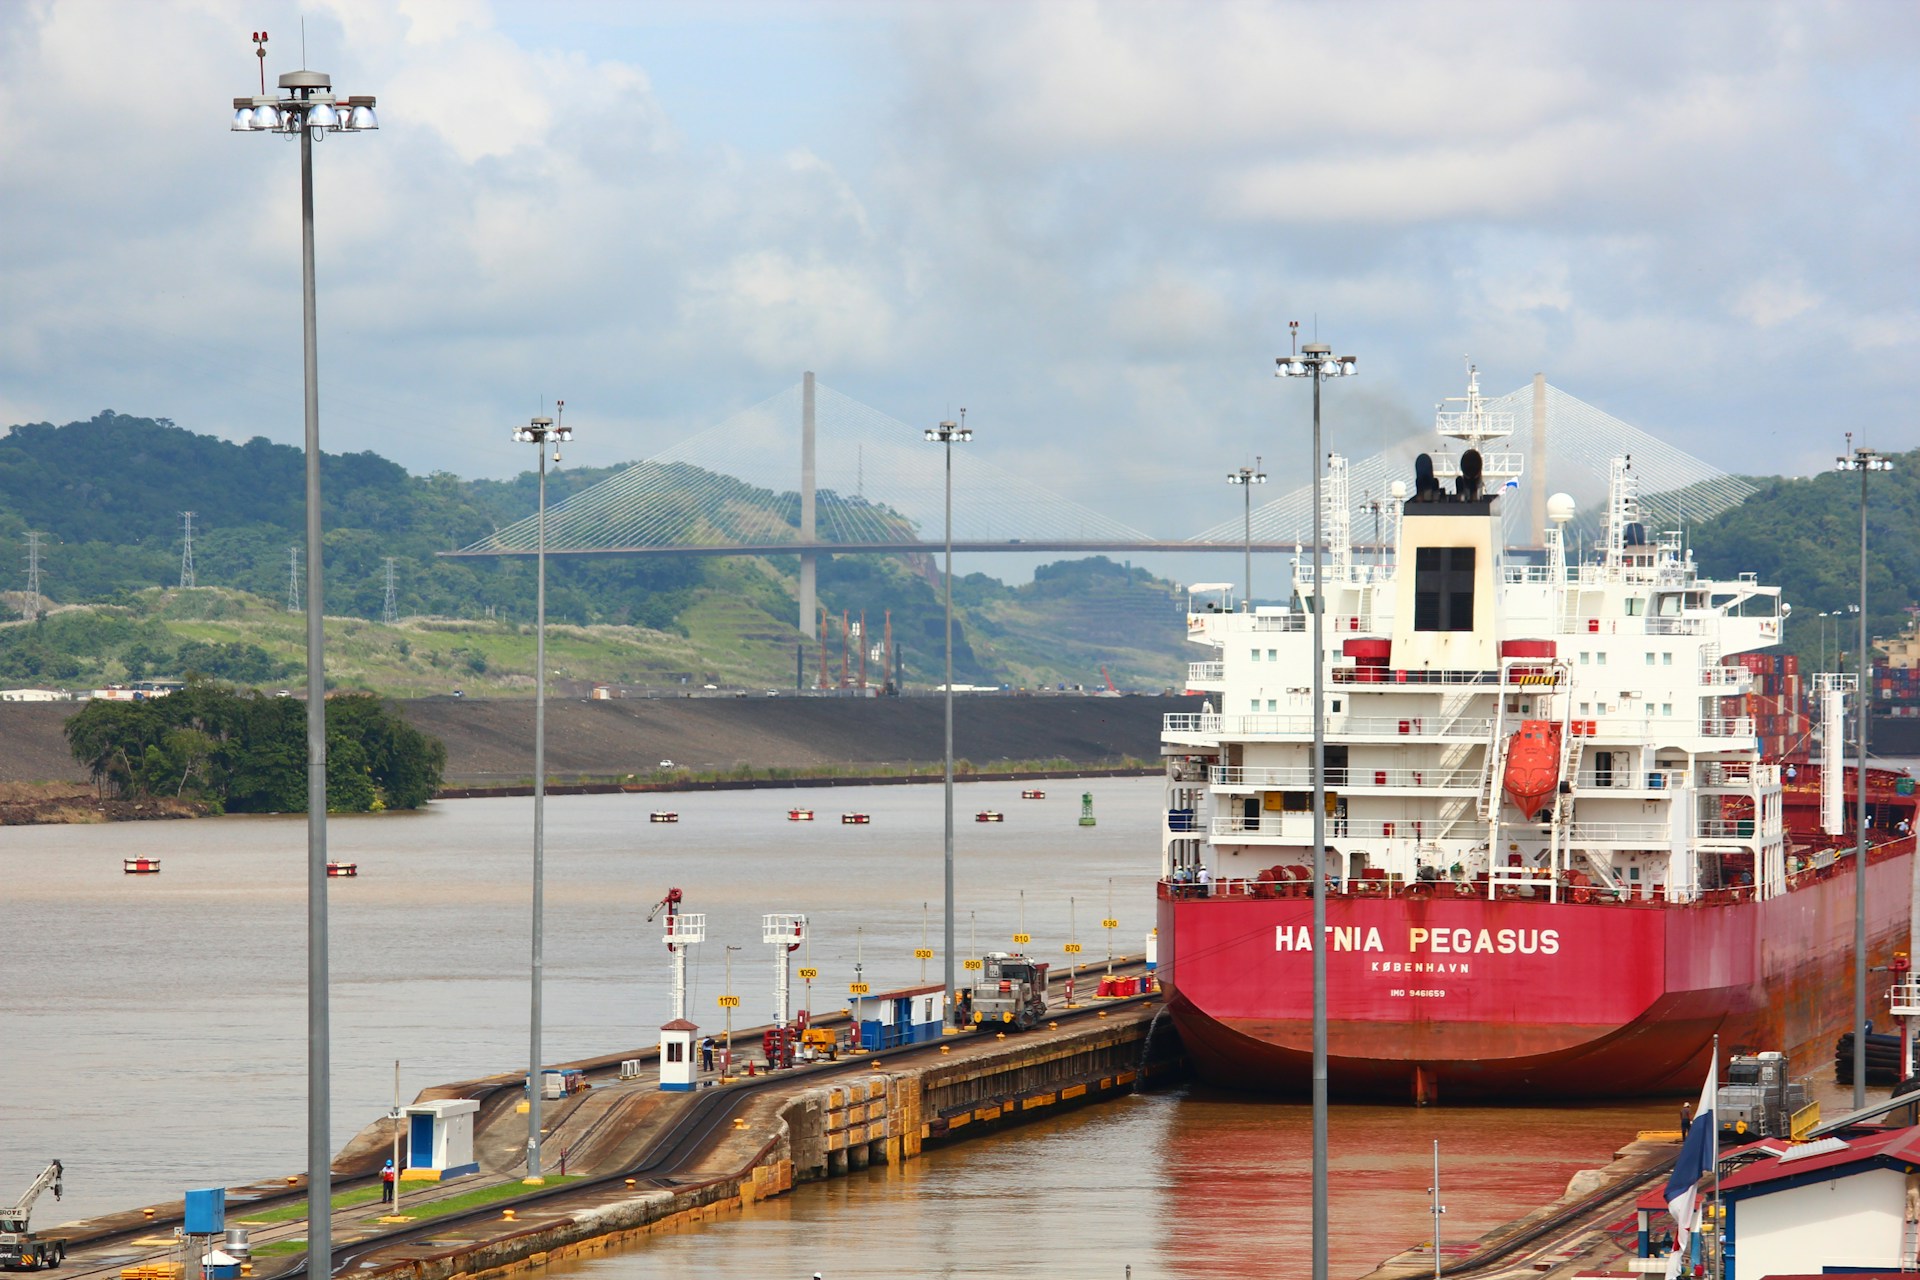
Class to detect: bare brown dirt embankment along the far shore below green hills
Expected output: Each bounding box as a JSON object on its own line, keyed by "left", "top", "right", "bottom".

{"left": 0, "top": 697, "right": 1194, "bottom": 796}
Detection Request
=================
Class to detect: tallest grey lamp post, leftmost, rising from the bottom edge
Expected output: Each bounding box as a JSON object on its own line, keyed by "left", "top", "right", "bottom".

{"left": 232, "top": 31, "right": 380, "bottom": 1280}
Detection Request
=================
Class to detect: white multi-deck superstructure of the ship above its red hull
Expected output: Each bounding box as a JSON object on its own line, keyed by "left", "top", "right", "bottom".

{"left": 1162, "top": 376, "right": 1788, "bottom": 900}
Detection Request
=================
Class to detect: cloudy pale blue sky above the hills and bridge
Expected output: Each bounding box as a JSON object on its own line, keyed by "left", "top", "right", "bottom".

{"left": 0, "top": 0, "right": 1920, "bottom": 556}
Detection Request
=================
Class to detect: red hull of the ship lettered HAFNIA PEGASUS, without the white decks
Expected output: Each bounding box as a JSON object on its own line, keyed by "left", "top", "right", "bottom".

{"left": 1160, "top": 846, "right": 1912, "bottom": 1102}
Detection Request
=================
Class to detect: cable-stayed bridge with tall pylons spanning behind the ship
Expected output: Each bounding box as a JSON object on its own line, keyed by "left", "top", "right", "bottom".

{"left": 442, "top": 374, "right": 1753, "bottom": 635}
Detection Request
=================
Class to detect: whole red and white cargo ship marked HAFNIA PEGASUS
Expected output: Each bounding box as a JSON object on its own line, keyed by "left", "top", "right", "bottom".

{"left": 1158, "top": 370, "right": 1914, "bottom": 1102}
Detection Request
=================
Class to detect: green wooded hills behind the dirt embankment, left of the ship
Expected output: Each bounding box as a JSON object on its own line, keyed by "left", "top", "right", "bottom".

{"left": 0, "top": 411, "right": 1188, "bottom": 695}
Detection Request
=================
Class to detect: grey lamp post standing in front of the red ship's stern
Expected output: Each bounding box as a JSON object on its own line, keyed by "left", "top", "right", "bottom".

{"left": 1275, "top": 320, "right": 1354, "bottom": 1280}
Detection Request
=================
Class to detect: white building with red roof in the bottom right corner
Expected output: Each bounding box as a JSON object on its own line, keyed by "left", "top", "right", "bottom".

{"left": 1720, "top": 1128, "right": 1920, "bottom": 1280}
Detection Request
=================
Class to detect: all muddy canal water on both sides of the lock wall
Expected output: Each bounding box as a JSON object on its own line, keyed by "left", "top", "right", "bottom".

{"left": 0, "top": 779, "right": 1672, "bottom": 1280}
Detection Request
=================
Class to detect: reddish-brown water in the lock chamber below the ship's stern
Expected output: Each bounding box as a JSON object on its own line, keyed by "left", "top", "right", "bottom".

{"left": 537, "top": 1092, "right": 1668, "bottom": 1280}
